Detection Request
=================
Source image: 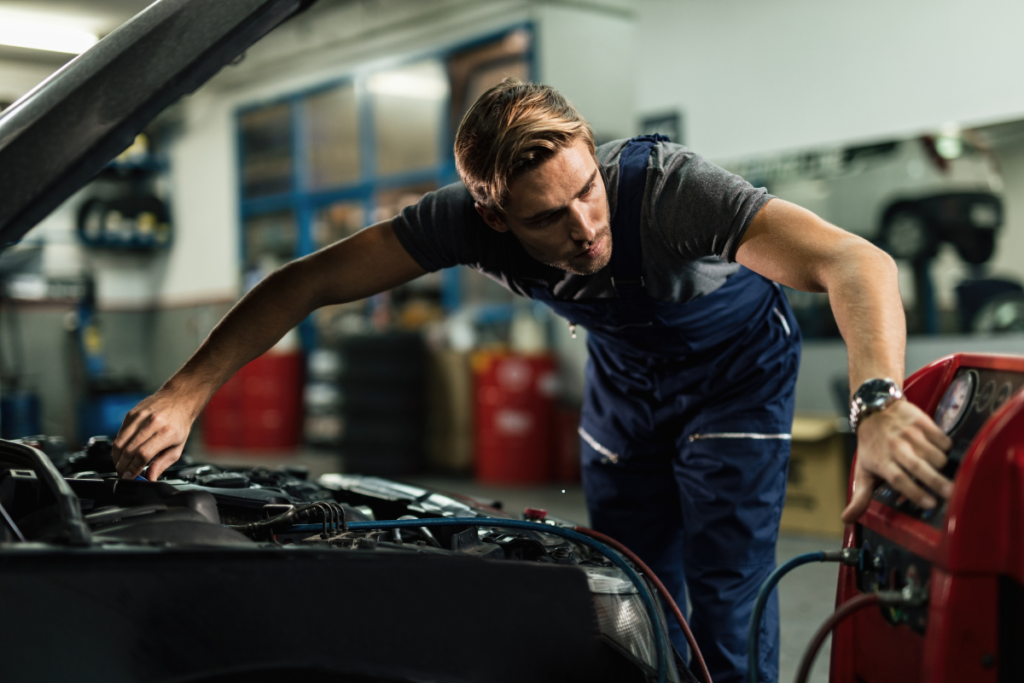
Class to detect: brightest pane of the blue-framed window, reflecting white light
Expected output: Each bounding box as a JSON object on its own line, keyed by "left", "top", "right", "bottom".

{"left": 367, "top": 60, "right": 449, "bottom": 175}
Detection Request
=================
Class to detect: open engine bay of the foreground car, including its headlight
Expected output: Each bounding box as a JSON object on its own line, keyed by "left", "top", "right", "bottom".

{"left": 0, "top": 437, "right": 695, "bottom": 681}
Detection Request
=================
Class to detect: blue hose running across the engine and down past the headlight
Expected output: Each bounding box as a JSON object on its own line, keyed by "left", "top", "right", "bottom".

{"left": 281, "top": 517, "right": 669, "bottom": 683}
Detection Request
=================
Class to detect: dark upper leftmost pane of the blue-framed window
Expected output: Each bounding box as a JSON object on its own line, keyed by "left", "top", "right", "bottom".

{"left": 242, "top": 103, "right": 292, "bottom": 197}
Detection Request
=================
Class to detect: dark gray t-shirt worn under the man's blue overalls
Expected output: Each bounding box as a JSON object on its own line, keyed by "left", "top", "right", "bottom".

{"left": 393, "top": 140, "right": 772, "bottom": 302}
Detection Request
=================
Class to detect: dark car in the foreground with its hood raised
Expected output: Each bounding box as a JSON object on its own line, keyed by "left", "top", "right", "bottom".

{"left": 0, "top": 0, "right": 695, "bottom": 683}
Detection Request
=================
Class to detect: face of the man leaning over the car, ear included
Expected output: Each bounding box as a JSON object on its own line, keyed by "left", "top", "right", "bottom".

{"left": 476, "top": 139, "right": 611, "bottom": 275}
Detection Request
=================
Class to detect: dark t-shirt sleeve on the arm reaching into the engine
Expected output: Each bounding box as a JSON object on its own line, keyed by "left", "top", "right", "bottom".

{"left": 391, "top": 182, "right": 484, "bottom": 272}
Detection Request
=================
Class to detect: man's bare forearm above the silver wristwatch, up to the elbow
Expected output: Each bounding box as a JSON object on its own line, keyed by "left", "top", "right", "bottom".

{"left": 821, "top": 238, "right": 906, "bottom": 391}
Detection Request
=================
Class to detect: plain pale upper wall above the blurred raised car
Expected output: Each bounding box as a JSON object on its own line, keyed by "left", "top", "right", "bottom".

{"left": 634, "top": 0, "right": 1024, "bottom": 158}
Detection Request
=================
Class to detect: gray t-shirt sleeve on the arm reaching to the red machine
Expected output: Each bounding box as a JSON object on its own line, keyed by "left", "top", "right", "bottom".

{"left": 648, "top": 145, "right": 772, "bottom": 262}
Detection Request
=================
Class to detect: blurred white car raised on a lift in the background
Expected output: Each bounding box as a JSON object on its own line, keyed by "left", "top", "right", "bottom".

{"left": 729, "top": 133, "right": 1004, "bottom": 265}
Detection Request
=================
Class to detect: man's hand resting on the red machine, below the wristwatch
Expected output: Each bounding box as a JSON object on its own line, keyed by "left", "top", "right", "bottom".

{"left": 843, "top": 399, "right": 953, "bottom": 523}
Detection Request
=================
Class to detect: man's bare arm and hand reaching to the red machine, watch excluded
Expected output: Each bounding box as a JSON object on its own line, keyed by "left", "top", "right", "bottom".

{"left": 736, "top": 199, "right": 952, "bottom": 522}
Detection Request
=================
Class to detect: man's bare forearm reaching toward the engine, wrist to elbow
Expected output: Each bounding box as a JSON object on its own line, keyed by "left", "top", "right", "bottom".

{"left": 163, "top": 260, "right": 317, "bottom": 417}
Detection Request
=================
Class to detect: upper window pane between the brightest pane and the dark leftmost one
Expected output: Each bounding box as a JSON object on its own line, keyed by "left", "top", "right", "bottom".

{"left": 306, "top": 85, "right": 359, "bottom": 189}
